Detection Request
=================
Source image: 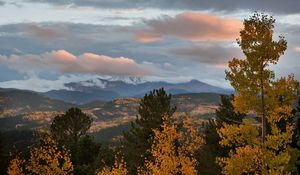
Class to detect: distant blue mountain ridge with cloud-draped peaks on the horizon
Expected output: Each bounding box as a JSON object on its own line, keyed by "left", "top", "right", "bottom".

{"left": 43, "top": 78, "right": 230, "bottom": 104}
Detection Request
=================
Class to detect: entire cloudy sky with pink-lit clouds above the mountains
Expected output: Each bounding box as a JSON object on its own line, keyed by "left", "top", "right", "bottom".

{"left": 0, "top": 0, "right": 300, "bottom": 92}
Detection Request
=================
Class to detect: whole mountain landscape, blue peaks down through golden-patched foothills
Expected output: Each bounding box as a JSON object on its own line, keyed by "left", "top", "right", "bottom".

{"left": 0, "top": 79, "right": 226, "bottom": 140}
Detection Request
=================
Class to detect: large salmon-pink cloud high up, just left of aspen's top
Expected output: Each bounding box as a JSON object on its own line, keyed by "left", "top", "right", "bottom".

{"left": 136, "top": 12, "right": 242, "bottom": 42}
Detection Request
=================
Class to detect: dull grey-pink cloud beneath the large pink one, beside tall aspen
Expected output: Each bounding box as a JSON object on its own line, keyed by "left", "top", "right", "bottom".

{"left": 170, "top": 43, "right": 243, "bottom": 67}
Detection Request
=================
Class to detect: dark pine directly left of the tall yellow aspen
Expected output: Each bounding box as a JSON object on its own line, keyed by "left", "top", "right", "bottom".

{"left": 196, "top": 95, "right": 246, "bottom": 174}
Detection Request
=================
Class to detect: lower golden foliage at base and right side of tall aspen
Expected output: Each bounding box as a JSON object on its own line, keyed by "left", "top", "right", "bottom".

{"left": 217, "top": 76, "right": 298, "bottom": 175}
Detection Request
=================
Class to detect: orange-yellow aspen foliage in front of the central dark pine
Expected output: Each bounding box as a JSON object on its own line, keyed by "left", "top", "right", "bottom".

{"left": 139, "top": 116, "right": 203, "bottom": 175}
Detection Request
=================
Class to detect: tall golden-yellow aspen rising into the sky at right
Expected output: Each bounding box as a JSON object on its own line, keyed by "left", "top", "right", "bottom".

{"left": 218, "top": 13, "right": 298, "bottom": 174}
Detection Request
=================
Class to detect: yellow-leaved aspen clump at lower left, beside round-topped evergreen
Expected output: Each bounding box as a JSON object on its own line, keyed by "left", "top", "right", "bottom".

{"left": 26, "top": 134, "right": 73, "bottom": 175}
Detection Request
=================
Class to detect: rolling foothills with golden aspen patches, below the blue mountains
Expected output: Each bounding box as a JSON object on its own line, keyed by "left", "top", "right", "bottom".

{"left": 0, "top": 86, "right": 220, "bottom": 141}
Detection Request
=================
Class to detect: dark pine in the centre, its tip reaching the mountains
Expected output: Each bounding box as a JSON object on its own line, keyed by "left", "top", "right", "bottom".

{"left": 123, "top": 88, "right": 176, "bottom": 173}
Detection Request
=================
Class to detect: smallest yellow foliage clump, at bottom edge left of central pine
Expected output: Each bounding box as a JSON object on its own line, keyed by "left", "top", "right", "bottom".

{"left": 97, "top": 158, "right": 128, "bottom": 175}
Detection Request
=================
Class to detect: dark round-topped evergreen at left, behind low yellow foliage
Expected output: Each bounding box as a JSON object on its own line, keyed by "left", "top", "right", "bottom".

{"left": 50, "top": 108, "right": 92, "bottom": 174}
